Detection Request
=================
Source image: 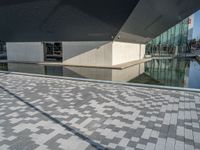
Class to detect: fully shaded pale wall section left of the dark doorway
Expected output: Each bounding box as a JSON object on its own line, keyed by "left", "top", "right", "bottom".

{"left": 6, "top": 42, "right": 44, "bottom": 62}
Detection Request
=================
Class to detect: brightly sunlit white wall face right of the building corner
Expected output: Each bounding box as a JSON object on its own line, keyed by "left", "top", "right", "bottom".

{"left": 112, "top": 42, "right": 145, "bottom": 65}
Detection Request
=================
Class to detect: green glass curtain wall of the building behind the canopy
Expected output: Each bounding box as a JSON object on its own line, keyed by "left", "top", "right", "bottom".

{"left": 146, "top": 18, "right": 189, "bottom": 57}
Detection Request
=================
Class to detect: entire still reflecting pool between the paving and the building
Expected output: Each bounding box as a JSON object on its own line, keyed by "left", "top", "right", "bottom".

{"left": 0, "top": 59, "right": 200, "bottom": 89}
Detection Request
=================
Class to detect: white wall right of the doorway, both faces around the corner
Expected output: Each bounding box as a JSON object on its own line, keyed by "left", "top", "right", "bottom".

{"left": 63, "top": 41, "right": 145, "bottom": 66}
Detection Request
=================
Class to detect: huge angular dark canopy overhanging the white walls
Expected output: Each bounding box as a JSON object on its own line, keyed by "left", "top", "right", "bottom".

{"left": 0, "top": 0, "right": 200, "bottom": 43}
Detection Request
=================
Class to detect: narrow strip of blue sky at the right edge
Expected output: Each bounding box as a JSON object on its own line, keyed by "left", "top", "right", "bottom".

{"left": 193, "top": 10, "right": 200, "bottom": 39}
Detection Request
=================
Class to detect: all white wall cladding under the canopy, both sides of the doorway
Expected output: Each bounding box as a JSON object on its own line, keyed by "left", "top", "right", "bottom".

{"left": 7, "top": 41, "right": 145, "bottom": 67}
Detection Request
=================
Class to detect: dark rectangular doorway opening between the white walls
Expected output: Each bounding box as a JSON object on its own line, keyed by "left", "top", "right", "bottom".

{"left": 44, "top": 42, "right": 63, "bottom": 62}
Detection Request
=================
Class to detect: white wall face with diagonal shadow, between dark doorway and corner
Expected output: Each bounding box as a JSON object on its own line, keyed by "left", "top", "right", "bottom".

{"left": 63, "top": 41, "right": 112, "bottom": 66}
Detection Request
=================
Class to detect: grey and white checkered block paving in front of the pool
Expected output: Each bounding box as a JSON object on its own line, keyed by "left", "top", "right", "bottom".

{"left": 0, "top": 73, "right": 200, "bottom": 150}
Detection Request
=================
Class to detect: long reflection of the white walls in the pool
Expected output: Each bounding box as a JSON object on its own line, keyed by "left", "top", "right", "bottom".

{"left": 3, "top": 63, "right": 144, "bottom": 81}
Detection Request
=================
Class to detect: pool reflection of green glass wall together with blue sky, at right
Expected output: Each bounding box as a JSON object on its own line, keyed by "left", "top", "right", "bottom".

{"left": 141, "top": 59, "right": 200, "bottom": 89}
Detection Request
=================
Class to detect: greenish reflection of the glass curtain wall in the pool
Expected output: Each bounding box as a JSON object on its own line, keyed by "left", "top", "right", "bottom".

{"left": 145, "top": 59, "right": 189, "bottom": 87}
